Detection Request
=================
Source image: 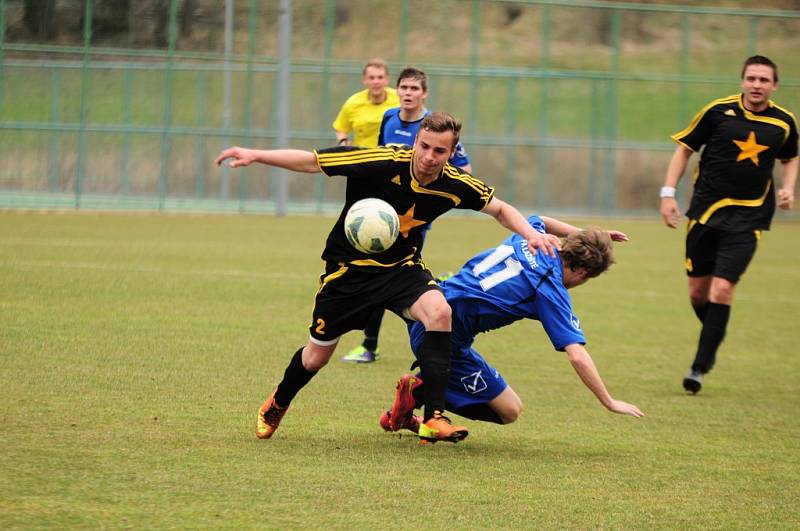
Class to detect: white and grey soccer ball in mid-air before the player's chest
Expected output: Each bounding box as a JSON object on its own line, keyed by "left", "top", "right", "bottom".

{"left": 344, "top": 197, "right": 400, "bottom": 254}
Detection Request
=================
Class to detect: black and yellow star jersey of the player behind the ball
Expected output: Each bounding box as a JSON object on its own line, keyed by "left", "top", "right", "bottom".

{"left": 315, "top": 146, "right": 494, "bottom": 267}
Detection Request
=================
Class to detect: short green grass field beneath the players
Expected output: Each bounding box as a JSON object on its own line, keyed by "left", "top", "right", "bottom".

{"left": 0, "top": 213, "right": 800, "bottom": 529}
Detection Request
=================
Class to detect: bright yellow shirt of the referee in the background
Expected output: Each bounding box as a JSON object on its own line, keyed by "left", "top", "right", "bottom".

{"left": 333, "top": 87, "right": 400, "bottom": 147}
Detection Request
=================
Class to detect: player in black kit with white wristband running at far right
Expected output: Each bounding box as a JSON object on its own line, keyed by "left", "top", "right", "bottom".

{"left": 661, "top": 55, "right": 798, "bottom": 393}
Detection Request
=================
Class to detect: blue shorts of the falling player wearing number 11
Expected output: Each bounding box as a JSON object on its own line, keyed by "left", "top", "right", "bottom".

{"left": 408, "top": 321, "right": 508, "bottom": 410}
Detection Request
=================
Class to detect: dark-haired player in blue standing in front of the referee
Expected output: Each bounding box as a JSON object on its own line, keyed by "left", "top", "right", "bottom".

{"left": 342, "top": 67, "right": 472, "bottom": 363}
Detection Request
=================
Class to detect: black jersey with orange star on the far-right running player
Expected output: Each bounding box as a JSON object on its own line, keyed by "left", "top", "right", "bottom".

{"left": 672, "top": 94, "right": 797, "bottom": 231}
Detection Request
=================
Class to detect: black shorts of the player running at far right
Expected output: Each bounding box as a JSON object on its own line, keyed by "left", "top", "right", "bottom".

{"left": 686, "top": 223, "right": 760, "bottom": 284}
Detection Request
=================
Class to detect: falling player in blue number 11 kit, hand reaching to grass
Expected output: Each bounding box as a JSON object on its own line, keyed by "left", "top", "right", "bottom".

{"left": 380, "top": 216, "right": 644, "bottom": 432}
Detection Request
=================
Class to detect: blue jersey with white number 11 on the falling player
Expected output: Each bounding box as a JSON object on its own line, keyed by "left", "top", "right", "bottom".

{"left": 411, "top": 216, "right": 586, "bottom": 351}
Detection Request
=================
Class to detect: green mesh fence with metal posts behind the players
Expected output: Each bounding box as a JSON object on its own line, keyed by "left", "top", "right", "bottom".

{"left": 0, "top": 0, "right": 800, "bottom": 216}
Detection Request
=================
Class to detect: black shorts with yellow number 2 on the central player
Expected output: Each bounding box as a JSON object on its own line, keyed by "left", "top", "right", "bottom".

{"left": 308, "top": 262, "right": 440, "bottom": 344}
